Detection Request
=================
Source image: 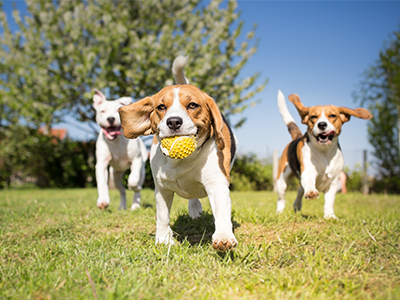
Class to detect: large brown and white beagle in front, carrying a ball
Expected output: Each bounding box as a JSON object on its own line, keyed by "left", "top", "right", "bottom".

{"left": 119, "top": 57, "right": 237, "bottom": 251}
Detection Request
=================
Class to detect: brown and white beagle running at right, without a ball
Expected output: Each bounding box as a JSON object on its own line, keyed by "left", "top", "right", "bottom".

{"left": 276, "top": 91, "right": 372, "bottom": 218}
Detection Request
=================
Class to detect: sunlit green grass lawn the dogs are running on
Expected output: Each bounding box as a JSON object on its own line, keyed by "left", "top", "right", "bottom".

{"left": 0, "top": 189, "right": 400, "bottom": 299}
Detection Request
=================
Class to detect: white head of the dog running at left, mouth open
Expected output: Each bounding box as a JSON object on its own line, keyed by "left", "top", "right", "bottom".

{"left": 93, "top": 90, "right": 132, "bottom": 140}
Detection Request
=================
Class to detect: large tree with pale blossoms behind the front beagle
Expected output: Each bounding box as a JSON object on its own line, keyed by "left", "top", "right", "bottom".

{"left": 0, "top": 0, "right": 266, "bottom": 132}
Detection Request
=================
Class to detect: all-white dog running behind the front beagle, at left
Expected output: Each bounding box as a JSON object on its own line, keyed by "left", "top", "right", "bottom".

{"left": 93, "top": 91, "right": 148, "bottom": 210}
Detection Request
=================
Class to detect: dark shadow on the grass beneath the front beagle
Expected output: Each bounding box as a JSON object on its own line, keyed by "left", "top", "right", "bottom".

{"left": 171, "top": 211, "right": 240, "bottom": 246}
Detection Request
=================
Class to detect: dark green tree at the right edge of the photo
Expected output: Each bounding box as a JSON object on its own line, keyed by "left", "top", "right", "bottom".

{"left": 355, "top": 27, "right": 400, "bottom": 191}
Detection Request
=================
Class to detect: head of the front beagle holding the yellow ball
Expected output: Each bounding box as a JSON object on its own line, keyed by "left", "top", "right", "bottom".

{"left": 119, "top": 85, "right": 225, "bottom": 151}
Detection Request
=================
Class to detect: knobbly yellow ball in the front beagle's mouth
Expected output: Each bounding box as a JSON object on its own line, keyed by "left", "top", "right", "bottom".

{"left": 161, "top": 135, "right": 197, "bottom": 159}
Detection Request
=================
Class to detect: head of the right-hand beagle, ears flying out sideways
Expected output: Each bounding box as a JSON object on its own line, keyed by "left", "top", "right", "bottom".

{"left": 289, "top": 94, "right": 372, "bottom": 145}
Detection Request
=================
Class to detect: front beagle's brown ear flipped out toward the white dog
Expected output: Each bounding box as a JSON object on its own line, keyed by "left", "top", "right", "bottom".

{"left": 118, "top": 97, "right": 154, "bottom": 139}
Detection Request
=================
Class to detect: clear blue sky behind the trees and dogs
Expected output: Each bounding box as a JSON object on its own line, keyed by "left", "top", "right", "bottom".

{"left": 3, "top": 0, "right": 400, "bottom": 171}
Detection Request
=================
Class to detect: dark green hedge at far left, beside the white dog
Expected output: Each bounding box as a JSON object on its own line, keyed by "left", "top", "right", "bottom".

{"left": 0, "top": 126, "right": 95, "bottom": 188}
